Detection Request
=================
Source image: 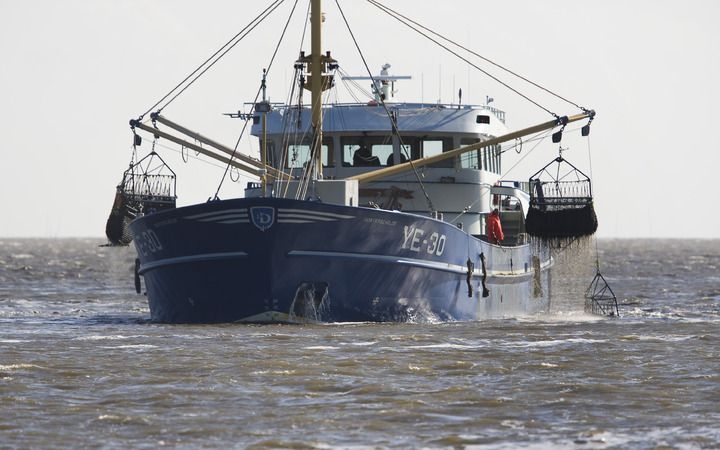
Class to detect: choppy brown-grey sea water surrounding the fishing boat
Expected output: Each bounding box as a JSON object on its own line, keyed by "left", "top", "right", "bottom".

{"left": 0, "top": 239, "right": 720, "bottom": 449}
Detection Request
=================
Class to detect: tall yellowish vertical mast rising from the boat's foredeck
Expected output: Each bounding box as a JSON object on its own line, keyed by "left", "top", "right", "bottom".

{"left": 310, "top": 0, "right": 324, "bottom": 179}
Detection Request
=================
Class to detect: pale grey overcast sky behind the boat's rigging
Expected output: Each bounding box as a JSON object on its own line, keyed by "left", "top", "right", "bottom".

{"left": 0, "top": 0, "right": 720, "bottom": 238}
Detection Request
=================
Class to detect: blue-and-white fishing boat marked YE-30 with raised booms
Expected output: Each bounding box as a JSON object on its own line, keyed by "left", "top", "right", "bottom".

{"left": 108, "top": 0, "right": 612, "bottom": 323}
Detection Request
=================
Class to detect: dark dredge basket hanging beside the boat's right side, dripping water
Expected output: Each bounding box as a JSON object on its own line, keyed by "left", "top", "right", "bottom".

{"left": 525, "top": 155, "right": 598, "bottom": 240}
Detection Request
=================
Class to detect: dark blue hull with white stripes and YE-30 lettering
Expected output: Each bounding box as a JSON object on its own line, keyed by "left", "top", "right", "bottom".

{"left": 131, "top": 198, "right": 550, "bottom": 323}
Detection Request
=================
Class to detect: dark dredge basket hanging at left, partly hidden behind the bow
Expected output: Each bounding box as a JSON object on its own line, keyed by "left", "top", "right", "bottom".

{"left": 105, "top": 151, "right": 177, "bottom": 245}
